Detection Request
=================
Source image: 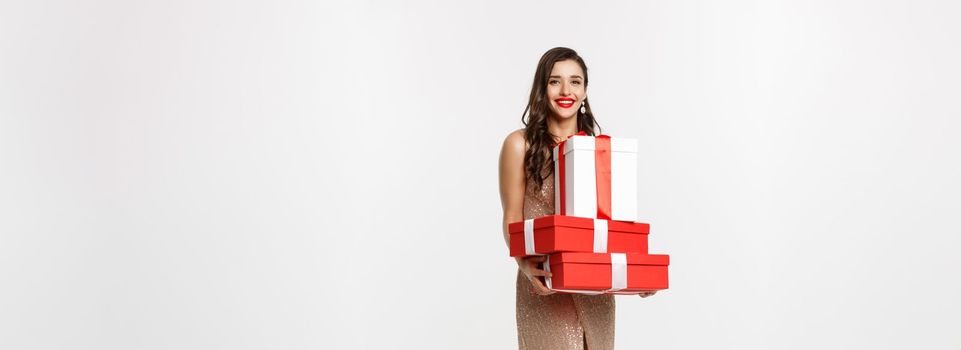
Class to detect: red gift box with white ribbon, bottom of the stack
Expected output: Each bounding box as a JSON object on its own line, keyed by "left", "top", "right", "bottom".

{"left": 544, "top": 253, "right": 670, "bottom": 294}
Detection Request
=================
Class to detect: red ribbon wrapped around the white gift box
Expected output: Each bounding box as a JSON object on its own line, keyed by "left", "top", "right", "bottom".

{"left": 555, "top": 131, "right": 611, "bottom": 220}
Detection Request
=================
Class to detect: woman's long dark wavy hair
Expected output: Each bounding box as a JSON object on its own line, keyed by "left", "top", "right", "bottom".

{"left": 521, "top": 47, "right": 600, "bottom": 188}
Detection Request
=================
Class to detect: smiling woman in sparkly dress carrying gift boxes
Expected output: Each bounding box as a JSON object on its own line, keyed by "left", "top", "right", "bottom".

{"left": 499, "top": 47, "right": 654, "bottom": 349}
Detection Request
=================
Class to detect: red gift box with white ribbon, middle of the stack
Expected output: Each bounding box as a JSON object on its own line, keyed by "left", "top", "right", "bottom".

{"left": 507, "top": 215, "right": 650, "bottom": 256}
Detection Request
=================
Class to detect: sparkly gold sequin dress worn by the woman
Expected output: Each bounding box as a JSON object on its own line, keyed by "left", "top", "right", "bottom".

{"left": 517, "top": 171, "right": 614, "bottom": 350}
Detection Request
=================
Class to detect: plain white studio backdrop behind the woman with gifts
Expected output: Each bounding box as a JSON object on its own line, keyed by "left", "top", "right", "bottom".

{"left": 0, "top": 0, "right": 961, "bottom": 349}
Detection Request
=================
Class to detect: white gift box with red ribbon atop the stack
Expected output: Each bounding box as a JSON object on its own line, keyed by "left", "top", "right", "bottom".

{"left": 553, "top": 135, "right": 637, "bottom": 221}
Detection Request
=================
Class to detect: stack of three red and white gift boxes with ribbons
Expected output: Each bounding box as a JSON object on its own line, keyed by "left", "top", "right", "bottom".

{"left": 508, "top": 133, "right": 670, "bottom": 294}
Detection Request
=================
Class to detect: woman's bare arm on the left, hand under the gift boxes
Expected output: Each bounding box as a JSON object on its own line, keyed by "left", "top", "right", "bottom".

{"left": 498, "top": 129, "right": 553, "bottom": 295}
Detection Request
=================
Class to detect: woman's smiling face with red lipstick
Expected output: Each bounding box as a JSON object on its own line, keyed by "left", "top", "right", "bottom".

{"left": 547, "top": 60, "right": 587, "bottom": 119}
